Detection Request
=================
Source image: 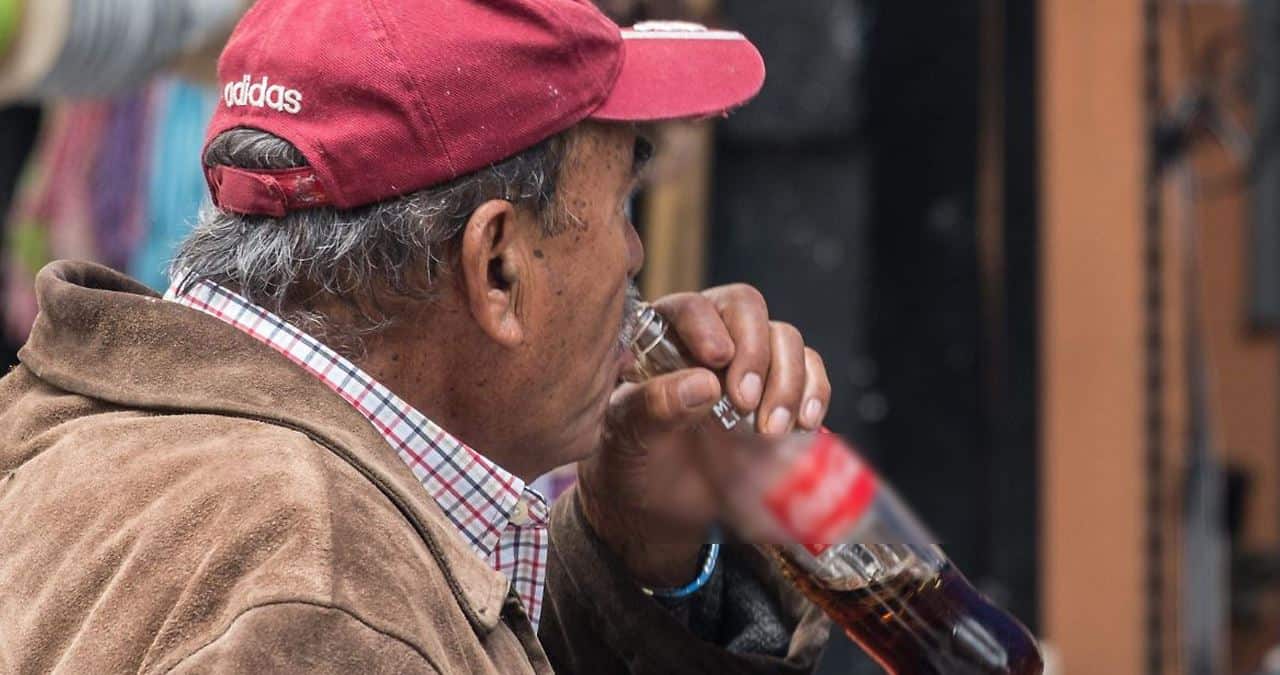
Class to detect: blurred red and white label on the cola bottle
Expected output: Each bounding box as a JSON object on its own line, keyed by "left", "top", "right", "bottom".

{"left": 764, "top": 433, "right": 878, "bottom": 556}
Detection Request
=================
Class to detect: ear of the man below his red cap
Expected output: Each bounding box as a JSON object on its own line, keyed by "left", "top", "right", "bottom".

{"left": 458, "top": 200, "right": 531, "bottom": 347}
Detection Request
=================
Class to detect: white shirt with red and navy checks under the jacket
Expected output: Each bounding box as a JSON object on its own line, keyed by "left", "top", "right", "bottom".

{"left": 165, "top": 282, "right": 548, "bottom": 629}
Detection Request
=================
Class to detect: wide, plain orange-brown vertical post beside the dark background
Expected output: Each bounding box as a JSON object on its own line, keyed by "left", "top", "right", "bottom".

{"left": 1039, "top": 0, "right": 1147, "bottom": 675}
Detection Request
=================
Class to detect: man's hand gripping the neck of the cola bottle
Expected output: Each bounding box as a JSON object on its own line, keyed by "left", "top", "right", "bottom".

{"left": 579, "top": 284, "right": 831, "bottom": 587}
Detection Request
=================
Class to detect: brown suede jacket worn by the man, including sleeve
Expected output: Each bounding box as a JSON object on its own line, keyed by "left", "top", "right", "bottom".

{"left": 0, "top": 263, "right": 827, "bottom": 675}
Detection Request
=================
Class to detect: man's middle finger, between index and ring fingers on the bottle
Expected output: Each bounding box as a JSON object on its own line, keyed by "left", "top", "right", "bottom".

{"left": 704, "top": 284, "right": 771, "bottom": 411}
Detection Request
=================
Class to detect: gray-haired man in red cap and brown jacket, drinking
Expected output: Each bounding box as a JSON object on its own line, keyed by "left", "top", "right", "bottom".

{"left": 0, "top": 0, "right": 829, "bottom": 674}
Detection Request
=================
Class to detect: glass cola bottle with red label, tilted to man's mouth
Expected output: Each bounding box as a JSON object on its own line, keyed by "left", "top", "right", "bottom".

{"left": 631, "top": 305, "right": 1043, "bottom": 675}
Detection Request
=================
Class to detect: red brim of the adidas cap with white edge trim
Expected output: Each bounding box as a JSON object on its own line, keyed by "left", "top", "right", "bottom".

{"left": 590, "top": 29, "right": 764, "bottom": 122}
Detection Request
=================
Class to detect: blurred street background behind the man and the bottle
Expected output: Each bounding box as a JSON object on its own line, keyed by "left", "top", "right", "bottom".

{"left": 0, "top": 0, "right": 1280, "bottom": 675}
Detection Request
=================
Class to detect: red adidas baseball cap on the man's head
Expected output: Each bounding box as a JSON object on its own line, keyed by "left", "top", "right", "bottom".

{"left": 206, "top": 0, "right": 764, "bottom": 216}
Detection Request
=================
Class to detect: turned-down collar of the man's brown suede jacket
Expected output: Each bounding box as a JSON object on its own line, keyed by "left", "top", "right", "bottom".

{"left": 19, "top": 261, "right": 508, "bottom": 633}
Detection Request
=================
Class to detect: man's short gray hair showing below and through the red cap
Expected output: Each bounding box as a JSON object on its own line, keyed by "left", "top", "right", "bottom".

{"left": 170, "top": 128, "right": 571, "bottom": 347}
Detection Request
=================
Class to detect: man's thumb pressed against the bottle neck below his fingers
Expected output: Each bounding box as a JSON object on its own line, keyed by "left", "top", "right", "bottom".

{"left": 609, "top": 368, "right": 722, "bottom": 439}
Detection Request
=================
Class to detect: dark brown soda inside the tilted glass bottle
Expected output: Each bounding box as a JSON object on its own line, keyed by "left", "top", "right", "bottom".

{"left": 774, "top": 551, "right": 1044, "bottom": 675}
